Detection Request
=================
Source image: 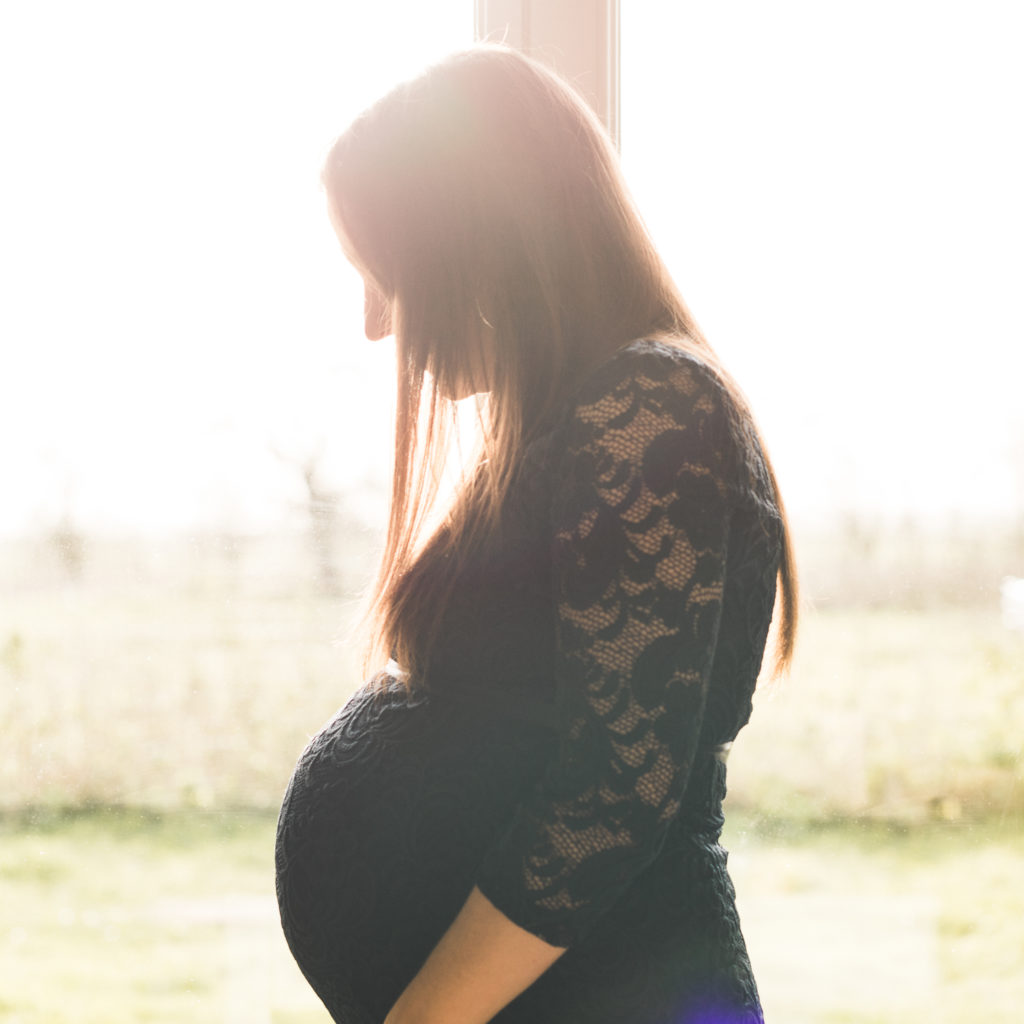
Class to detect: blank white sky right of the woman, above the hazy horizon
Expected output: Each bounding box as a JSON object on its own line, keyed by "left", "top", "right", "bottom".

{"left": 623, "top": 0, "right": 1024, "bottom": 517}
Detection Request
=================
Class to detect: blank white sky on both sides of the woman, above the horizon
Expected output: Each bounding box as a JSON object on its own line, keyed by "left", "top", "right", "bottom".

{"left": 0, "top": 0, "right": 1024, "bottom": 532}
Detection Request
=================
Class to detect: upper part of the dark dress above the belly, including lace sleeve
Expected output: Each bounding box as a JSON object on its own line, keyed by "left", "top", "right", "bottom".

{"left": 414, "top": 341, "right": 780, "bottom": 945}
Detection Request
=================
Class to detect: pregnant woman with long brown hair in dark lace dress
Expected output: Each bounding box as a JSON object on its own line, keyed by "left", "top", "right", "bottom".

{"left": 276, "top": 41, "right": 796, "bottom": 1024}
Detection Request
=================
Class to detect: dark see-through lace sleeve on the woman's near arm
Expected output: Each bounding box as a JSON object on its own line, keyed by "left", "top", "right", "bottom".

{"left": 477, "top": 348, "right": 730, "bottom": 946}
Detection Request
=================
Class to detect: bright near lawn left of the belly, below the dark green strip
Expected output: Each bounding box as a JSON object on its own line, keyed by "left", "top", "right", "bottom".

{"left": 0, "top": 810, "right": 329, "bottom": 1024}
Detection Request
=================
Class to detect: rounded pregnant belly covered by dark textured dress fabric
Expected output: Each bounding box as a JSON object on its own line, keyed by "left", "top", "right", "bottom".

{"left": 276, "top": 686, "right": 551, "bottom": 1021}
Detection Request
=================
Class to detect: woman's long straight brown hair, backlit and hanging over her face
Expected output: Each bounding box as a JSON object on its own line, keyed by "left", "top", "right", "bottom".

{"left": 324, "top": 45, "right": 797, "bottom": 678}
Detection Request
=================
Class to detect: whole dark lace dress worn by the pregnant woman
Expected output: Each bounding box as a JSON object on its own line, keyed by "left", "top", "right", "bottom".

{"left": 276, "top": 341, "right": 780, "bottom": 1024}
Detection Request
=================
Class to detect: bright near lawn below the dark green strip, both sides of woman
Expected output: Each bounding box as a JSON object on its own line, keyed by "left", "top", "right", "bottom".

{"left": 0, "top": 809, "right": 1024, "bottom": 1024}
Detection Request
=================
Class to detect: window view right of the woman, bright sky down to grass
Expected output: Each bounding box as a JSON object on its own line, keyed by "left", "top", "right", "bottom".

{"left": 622, "top": 0, "right": 1024, "bottom": 1022}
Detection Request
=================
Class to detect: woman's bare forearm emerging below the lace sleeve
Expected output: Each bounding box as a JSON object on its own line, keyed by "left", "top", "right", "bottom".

{"left": 384, "top": 888, "right": 565, "bottom": 1024}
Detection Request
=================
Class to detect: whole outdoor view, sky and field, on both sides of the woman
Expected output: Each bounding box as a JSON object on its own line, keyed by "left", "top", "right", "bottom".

{"left": 0, "top": 0, "right": 1024, "bottom": 1024}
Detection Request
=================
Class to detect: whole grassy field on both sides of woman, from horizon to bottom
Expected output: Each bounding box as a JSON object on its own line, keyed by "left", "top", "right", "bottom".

{"left": 0, "top": 539, "right": 1024, "bottom": 1024}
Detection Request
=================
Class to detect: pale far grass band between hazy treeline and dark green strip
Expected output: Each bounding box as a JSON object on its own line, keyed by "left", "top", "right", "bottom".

{"left": 0, "top": 586, "right": 1024, "bottom": 821}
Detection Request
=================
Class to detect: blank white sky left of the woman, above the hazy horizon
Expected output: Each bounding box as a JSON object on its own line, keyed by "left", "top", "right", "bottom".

{"left": 0, "top": 0, "right": 473, "bottom": 531}
